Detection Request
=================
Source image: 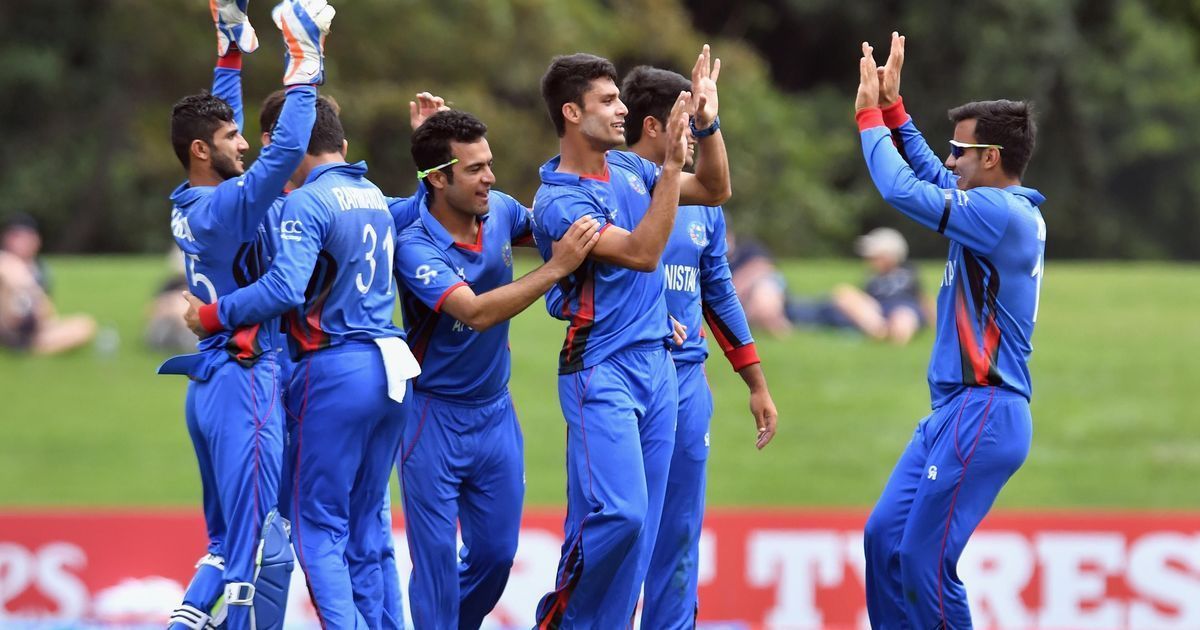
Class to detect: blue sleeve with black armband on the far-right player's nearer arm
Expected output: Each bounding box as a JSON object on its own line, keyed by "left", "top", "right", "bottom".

{"left": 859, "top": 126, "right": 1009, "bottom": 256}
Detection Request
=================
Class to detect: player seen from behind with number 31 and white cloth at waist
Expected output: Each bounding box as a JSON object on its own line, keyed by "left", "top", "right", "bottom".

{"left": 184, "top": 101, "right": 419, "bottom": 628}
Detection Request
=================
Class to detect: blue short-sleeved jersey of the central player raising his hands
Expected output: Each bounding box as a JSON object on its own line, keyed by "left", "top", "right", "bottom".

{"left": 534, "top": 151, "right": 671, "bottom": 374}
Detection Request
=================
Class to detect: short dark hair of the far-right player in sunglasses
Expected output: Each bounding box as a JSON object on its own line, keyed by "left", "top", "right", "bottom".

{"left": 949, "top": 100, "right": 1038, "bottom": 179}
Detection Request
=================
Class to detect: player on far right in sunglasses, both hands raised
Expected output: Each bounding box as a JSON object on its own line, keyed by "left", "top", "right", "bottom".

{"left": 854, "top": 34, "right": 1046, "bottom": 630}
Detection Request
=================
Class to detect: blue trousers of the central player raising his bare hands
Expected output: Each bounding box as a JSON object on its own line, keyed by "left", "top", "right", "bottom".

{"left": 536, "top": 343, "right": 679, "bottom": 629}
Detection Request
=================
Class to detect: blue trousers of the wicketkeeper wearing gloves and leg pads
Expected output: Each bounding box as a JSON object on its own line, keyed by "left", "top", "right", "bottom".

{"left": 184, "top": 355, "right": 283, "bottom": 630}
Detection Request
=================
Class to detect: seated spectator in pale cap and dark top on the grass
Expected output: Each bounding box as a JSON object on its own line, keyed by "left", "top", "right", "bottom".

{"left": 787, "top": 228, "right": 931, "bottom": 346}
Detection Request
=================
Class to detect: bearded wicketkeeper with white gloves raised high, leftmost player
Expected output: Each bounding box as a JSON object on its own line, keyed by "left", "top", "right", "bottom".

{"left": 160, "top": 0, "right": 334, "bottom": 629}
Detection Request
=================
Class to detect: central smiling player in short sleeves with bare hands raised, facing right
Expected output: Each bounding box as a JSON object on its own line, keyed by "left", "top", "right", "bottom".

{"left": 534, "top": 46, "right": 730, "bottom": 628}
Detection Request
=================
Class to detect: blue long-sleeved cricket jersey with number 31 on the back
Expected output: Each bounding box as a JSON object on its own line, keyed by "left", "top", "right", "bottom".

{"left": 210, "top": 162, "right": 403, "bottom": 356}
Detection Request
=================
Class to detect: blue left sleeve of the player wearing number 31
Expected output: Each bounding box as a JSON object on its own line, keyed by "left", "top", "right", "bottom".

{"left": 210, "top": 190, "right": 331, "bottom": 329}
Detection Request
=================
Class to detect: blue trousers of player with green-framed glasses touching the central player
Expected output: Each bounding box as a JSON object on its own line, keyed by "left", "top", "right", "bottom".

{"left": 397, "top": 390, "right": 524, "bottom": 630}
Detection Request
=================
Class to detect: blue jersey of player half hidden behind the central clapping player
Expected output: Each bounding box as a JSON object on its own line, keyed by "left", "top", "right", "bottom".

{"left": 662, "top": 205, "right": 758, "bottom": 370}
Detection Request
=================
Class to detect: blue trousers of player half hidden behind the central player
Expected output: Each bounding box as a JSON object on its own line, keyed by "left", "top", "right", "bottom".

{"left": 642, "top": 362, "right": 713, "bottom": 630}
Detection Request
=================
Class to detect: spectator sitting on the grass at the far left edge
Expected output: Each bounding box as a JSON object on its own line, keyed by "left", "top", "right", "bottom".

{"left": 0, "top": 215, "right": 96, "bottom": 355}
